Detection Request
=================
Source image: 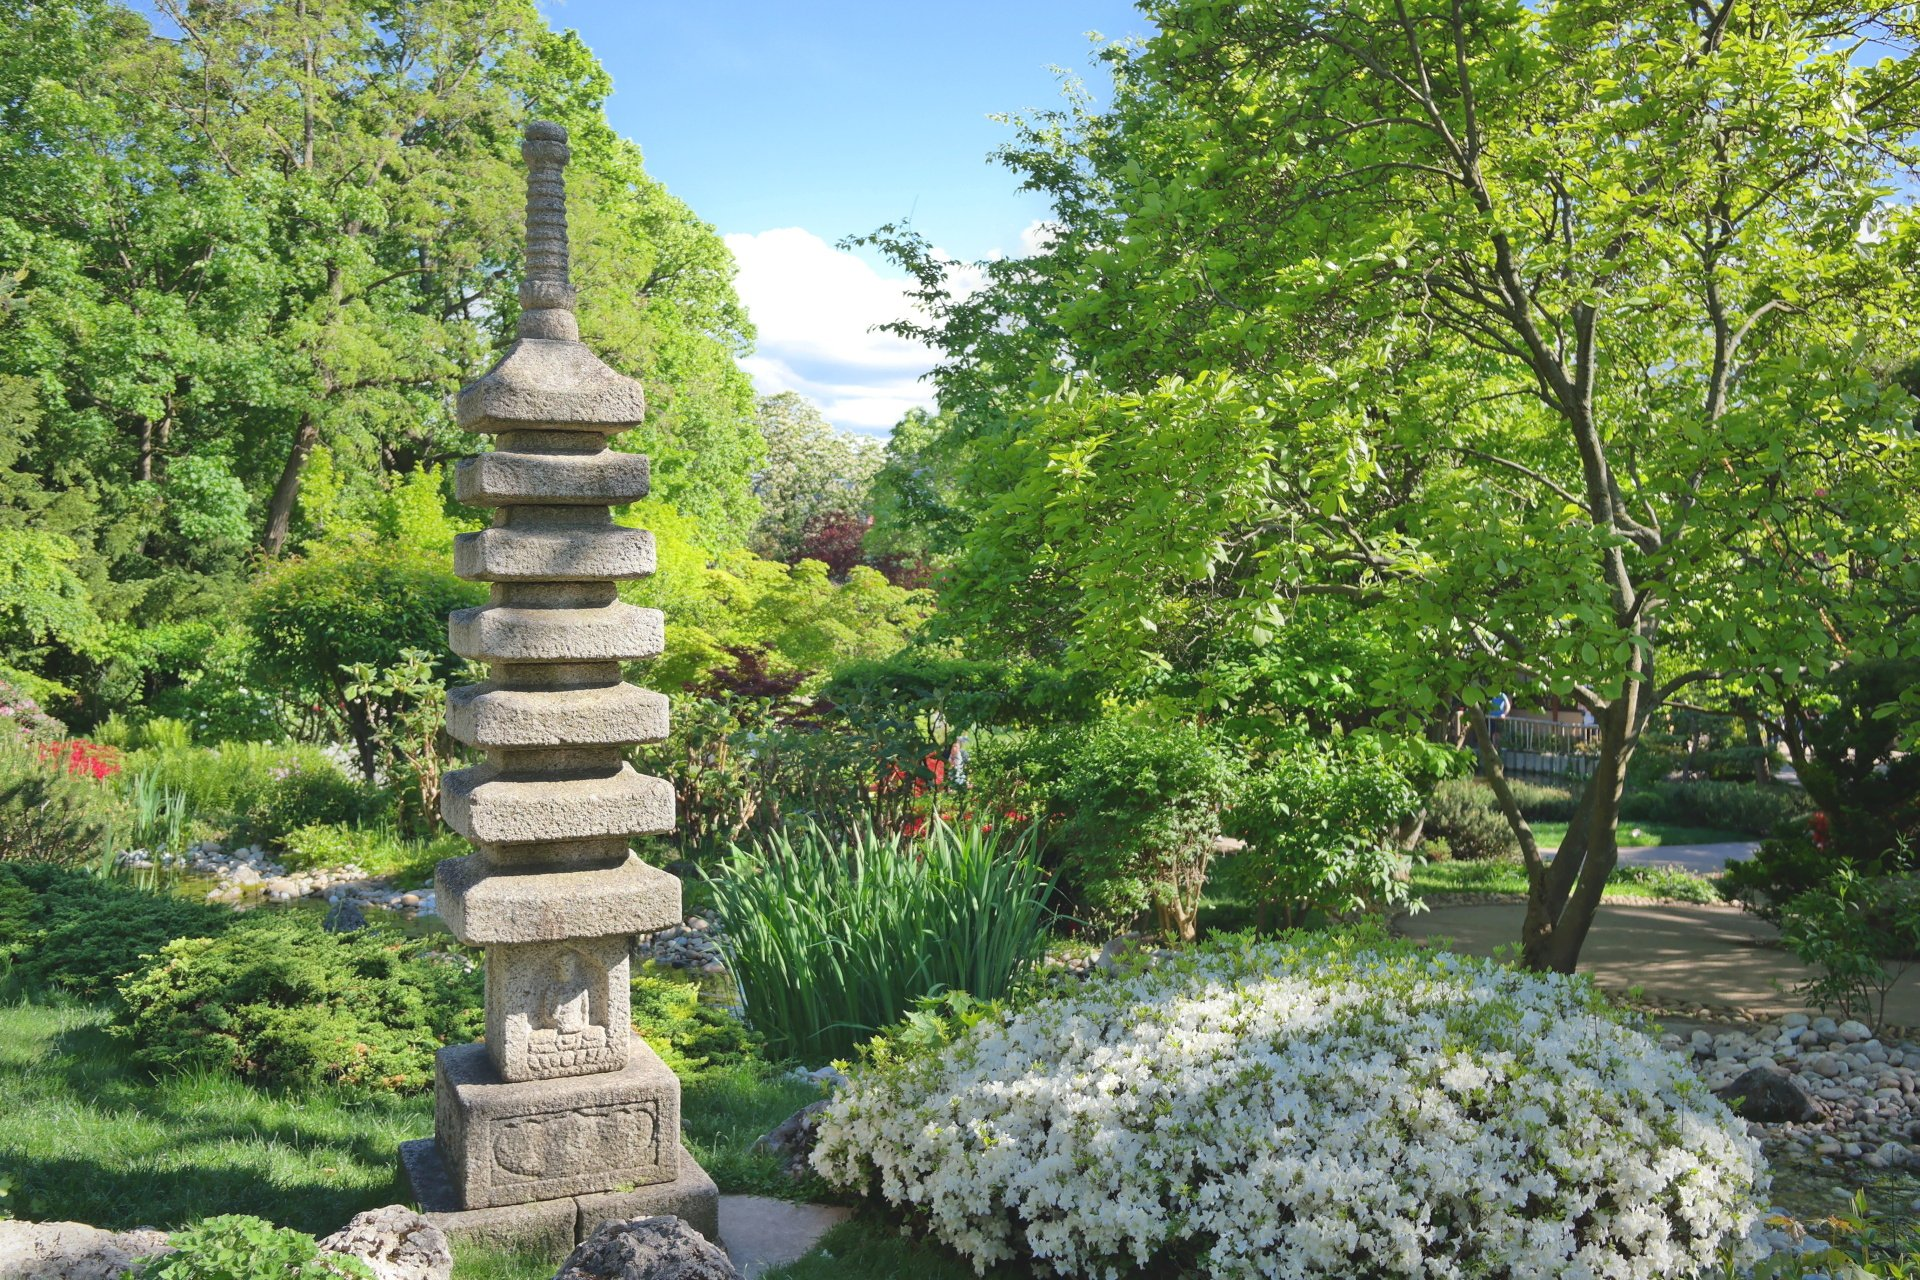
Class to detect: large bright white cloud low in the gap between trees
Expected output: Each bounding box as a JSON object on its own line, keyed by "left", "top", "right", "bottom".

{"left": 726, "top": 226, "right": 935, "bottom": 445}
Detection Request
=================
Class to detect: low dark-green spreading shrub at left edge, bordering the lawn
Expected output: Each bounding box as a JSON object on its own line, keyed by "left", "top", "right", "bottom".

{"left": 0, "top": 864, "right": 236, "bottom": 1000}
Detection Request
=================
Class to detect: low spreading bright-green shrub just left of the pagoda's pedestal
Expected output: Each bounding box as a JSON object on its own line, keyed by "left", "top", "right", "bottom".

{"left": 115, "top": 912, "right": 482, "bottom": 1092}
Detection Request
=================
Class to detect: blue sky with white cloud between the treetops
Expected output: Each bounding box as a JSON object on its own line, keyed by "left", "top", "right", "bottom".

{"left": 543, "top": 0, "right": 1146, "bottom": 434}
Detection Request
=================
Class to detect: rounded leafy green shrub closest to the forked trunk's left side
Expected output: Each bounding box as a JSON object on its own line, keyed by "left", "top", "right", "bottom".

{"left": 1223, "top": 739, "right": 1421, "bottom": 929}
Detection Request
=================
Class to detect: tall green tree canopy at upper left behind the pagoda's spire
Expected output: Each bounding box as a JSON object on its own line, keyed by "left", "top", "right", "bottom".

{"left": 0, "top": 0, "right": 762, "bottom": 633}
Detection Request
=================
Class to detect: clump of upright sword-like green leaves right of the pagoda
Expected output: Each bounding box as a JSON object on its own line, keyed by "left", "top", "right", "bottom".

{"left": 712, "top": 823, "right": 1048, "bottom": 1063}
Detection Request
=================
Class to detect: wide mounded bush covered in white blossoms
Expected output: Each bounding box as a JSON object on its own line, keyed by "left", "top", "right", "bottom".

{"left": 812, "top": 933, "right": 1764, "bottom": 1280}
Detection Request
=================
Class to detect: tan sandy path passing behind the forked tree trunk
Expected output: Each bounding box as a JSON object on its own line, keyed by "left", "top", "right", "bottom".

{"left": 1396, "top": 902, "right": 1920, "bottom": 1027}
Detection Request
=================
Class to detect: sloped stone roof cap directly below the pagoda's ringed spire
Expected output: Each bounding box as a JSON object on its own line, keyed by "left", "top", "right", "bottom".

{"left": 455, "top": 338, "right": 647, "bottom": 434}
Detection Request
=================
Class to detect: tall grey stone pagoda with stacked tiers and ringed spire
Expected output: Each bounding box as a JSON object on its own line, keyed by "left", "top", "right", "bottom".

{"left": 401, "top": 123, "right": 718, "bottom": 1253}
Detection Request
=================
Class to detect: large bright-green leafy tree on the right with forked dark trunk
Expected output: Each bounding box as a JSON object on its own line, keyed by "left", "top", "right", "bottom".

{"left": 881, "top": 0, "right": 1920, "bottom": 969}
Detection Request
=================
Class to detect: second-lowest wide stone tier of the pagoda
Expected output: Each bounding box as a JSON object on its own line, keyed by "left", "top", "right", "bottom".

{"left": 440, "top": 764, "right": 674, "bottom": 844}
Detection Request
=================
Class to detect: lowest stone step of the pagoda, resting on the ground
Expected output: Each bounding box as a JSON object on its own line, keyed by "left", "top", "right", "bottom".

{"left": 399, "top": 1138, "right": 720, "bottom": 1261}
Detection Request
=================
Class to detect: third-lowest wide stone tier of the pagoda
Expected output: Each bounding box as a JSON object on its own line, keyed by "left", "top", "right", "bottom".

{"left": 447, "top": 681, "right": 666, "bottom": 747}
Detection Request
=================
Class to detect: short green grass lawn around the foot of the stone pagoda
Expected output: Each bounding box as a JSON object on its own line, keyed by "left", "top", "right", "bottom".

{"left": 0, "top": 1000, "right": 817, "bottom": 1280}
